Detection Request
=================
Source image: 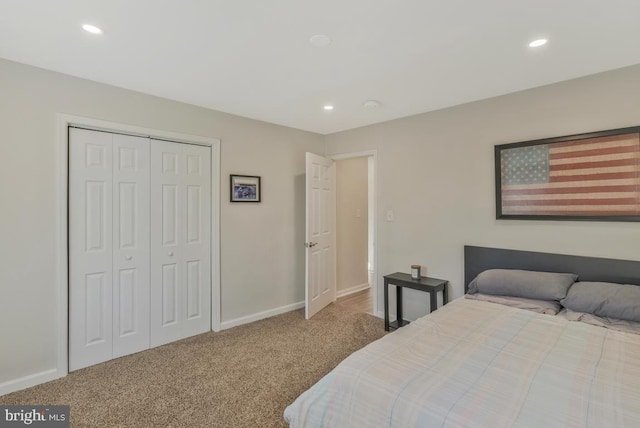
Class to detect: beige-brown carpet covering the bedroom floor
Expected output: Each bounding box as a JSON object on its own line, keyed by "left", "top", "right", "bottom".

{"left": 0, "top": 304, "right": 384, "bottom": 428}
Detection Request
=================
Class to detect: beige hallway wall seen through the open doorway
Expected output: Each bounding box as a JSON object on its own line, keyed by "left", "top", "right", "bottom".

{"left": 336, "top": 158, "right": 368, "bottom": 293}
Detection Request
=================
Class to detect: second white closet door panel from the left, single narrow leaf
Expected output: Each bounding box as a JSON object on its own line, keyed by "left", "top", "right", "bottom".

{"left": 113, "top": 134, "right": 150, "bottom": 357}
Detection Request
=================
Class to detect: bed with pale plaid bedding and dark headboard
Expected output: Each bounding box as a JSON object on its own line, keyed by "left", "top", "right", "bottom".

{"left": 284, "top": 246, "right": 640, "bottom": 428}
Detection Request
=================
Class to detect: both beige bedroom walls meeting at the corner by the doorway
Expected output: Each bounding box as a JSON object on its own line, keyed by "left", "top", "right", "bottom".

{"left": 0, "top": 56, "right": 640, "bottom": 392}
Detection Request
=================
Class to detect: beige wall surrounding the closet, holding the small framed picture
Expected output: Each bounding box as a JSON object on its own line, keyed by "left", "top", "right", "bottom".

{"left": 0, "top": 60, "right": 324, "bottom": 386}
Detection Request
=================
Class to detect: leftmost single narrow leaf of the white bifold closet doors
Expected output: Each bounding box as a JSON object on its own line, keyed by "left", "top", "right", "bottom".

{"left": 69, "top": 128, "right": 113, "bottom": 370}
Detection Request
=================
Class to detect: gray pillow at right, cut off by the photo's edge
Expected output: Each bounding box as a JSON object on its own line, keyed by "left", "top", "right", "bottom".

{"left": 560, "top": 282, "right": 640, "bottom": 322}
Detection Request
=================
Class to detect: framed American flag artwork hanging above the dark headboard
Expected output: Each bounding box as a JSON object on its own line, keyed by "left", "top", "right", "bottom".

{"left": 495, "top": 126, "right": 640, "bottom": 221}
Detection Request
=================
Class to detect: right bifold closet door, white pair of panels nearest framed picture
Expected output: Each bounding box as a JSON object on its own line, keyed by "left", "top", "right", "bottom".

{"left": 151, "top": 141, "right": 211, "bottom": 346}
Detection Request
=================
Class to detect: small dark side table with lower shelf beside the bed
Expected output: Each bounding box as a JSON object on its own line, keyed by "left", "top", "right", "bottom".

{"left": 384, "top": 272, "right": 449, "bottom": 331}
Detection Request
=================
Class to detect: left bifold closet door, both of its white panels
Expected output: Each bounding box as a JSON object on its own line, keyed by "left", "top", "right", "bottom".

{"left": 69, "top": 128, "right": 149, "bottom": 370}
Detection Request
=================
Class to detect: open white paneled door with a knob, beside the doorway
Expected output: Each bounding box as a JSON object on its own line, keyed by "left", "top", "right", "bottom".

{"left": 305, "top": 153, "right": 336, "bottom": 319}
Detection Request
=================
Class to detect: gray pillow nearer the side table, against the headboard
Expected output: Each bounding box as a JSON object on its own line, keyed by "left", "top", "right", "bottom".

{"left": 469, "top": 269, "right": 578, "bottom": 300}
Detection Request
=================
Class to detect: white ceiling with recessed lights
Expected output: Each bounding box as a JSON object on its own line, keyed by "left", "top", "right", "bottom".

{"left": 0, "top": 0, "right": 640, "bottom": 134}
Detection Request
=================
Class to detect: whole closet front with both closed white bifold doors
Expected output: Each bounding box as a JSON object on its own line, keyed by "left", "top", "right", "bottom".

{"left": 69, "top": 128, "right": 211, "bottom": 370}
